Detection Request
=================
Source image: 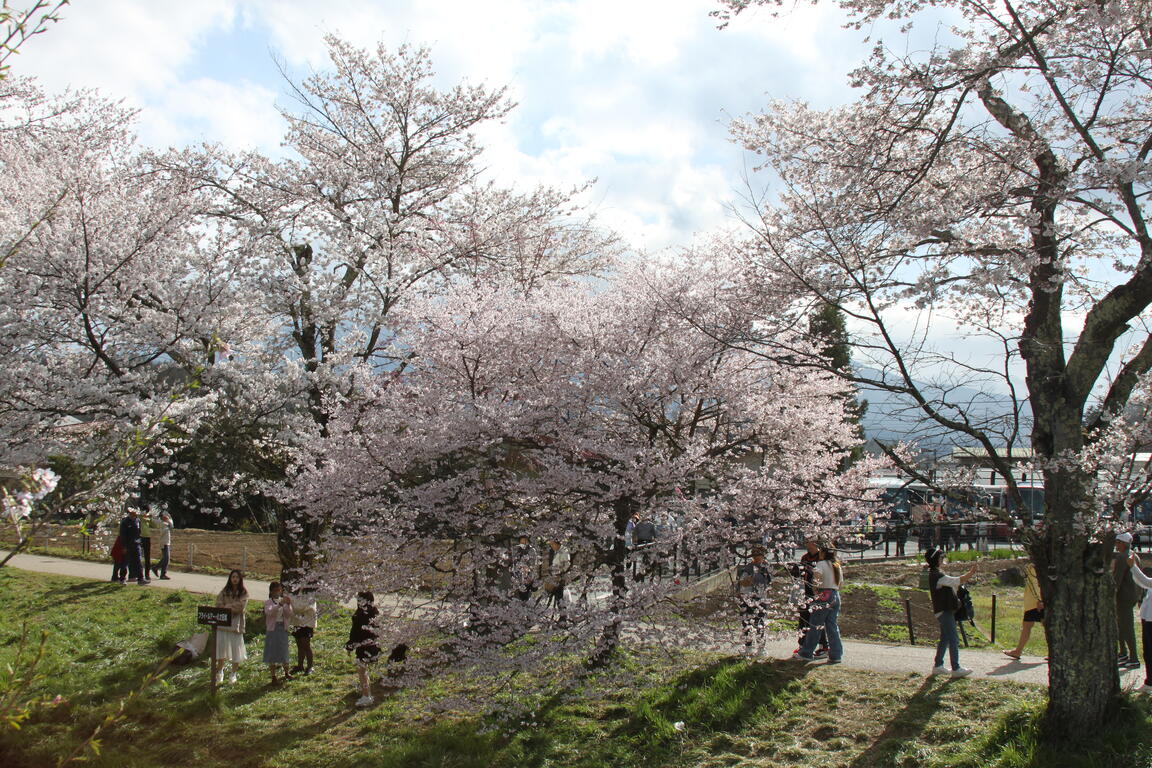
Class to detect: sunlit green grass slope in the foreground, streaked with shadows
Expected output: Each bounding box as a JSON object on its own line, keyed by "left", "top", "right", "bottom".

{"left": 0, "top": 569, "right": 1152, "bottom": 768}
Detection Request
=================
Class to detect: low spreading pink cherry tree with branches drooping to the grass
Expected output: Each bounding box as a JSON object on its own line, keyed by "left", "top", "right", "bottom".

{"left": 289, "top": 264, "right": 871, "bottom": 669}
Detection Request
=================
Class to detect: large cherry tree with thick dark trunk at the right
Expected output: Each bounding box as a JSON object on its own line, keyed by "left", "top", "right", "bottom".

{"left": 725, "top": 0, "right": 1152, "bottom": 739}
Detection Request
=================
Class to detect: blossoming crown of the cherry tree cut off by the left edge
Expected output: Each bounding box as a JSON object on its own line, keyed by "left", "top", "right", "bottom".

{"left": 0, "top": 78, "right": 256, "bottom": 529}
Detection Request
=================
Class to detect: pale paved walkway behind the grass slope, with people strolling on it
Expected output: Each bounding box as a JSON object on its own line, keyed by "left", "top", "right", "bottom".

{"left": 0, "top": 553, "right": 1144, "bottom": 689}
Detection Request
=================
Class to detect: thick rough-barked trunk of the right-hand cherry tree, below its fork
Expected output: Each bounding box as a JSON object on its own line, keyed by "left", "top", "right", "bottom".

{"left": 1032, "top": 470, "right": 1120, "bottom": 743}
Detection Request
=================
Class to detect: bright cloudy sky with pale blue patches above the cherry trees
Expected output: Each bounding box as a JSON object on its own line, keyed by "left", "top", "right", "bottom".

{"left": 13, "top": 0, "right": 865, "bottom": 250}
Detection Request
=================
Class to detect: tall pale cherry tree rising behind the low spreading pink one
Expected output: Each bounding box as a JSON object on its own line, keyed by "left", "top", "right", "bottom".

{"left": 157, "top": 38, "right": 614, "bottom": 569}
